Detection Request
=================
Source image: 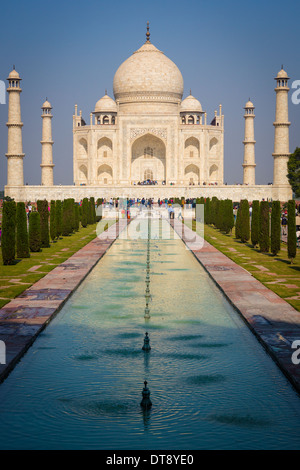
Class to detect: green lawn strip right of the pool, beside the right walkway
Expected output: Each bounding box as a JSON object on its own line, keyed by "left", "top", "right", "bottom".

{"left": 186, "top": 221, "right": 300, "bottom": 311}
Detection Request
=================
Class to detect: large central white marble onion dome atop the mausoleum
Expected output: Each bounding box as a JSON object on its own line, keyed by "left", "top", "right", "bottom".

{"left": 113, "top": 41, "right": 183, "bottom": 101}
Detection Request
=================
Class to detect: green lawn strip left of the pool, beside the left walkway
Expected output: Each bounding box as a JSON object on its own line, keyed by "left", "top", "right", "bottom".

{"left": 0, "top": 220, "right": 113, "bottom": 308}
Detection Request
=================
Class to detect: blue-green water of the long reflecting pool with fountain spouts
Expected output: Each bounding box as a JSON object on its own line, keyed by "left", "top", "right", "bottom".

{"left": 0, "top": 222, "right": 300, "bottom": 450}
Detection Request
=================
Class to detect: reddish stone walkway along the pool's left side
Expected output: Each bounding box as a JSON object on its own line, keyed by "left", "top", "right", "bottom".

{"left": 0, "top": 219, "right": 127, "bottom": 383}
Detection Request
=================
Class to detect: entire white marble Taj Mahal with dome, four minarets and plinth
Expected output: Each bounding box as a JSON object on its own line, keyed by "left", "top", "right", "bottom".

{"left": 5, "top": 24, "right": 292, "bottom": 201}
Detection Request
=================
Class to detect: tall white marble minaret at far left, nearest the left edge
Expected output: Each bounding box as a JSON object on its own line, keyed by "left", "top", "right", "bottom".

{"left": 6, "top": 66, "right": 25, "bottom": 186}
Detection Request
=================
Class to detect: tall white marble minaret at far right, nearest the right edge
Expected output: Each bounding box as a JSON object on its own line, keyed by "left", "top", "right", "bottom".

{"left": 273, "top": 67, "right": 291, "bottom": 188}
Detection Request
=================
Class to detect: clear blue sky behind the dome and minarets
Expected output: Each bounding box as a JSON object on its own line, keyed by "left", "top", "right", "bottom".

{"left": 0, "top": 0, "right": 300, "bottom": 189}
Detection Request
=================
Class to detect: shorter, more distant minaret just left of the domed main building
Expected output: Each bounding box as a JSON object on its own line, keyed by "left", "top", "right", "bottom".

{"left": 41, "top": 98, "right": 54, "bottom": 186}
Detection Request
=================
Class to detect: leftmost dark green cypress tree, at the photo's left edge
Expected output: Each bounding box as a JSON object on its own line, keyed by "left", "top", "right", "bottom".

{"left": 1, "top": 201, "right": 16, "bottom": 265}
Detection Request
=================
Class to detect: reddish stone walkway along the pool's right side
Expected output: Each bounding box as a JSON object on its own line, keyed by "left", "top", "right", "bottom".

{"left": 171, "top": 219, "right": 300, "bottom": 393}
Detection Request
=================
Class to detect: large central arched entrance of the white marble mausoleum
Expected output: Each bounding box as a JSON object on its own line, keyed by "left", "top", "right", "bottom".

{"left": 131, "top": 134, "right": 166, "bottom": 183}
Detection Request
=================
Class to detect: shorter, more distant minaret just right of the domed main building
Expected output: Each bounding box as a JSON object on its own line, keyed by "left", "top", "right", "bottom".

{"left": 243, "top": 98, "right": 256, "bottom": 185}
